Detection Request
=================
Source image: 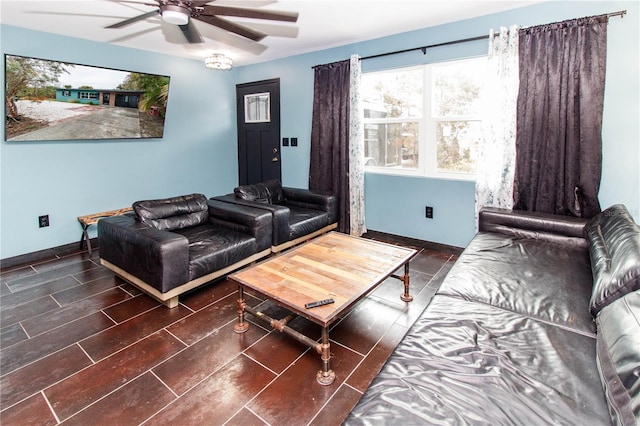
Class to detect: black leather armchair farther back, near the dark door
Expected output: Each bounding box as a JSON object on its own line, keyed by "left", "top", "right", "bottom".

{"left": 211, "top": 179, "right": 338, "bottom": 253}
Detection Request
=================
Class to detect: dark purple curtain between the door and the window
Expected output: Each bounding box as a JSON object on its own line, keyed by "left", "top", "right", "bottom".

{"left": 309, "top": 60, "right": 350, "bottom": 233}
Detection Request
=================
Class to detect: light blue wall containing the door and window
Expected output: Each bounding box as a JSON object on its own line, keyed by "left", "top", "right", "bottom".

{"left": 237, "top": 1, "right": 640, "bottom": 247}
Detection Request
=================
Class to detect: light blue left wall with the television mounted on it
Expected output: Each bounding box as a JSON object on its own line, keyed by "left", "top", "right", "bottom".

{"left": 0, "top": 25, "right": 238, "bottom": 259}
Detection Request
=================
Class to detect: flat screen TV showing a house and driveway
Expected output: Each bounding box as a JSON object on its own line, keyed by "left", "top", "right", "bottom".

{"left": 4, "top": 55, "right": 169, "bottom": 142}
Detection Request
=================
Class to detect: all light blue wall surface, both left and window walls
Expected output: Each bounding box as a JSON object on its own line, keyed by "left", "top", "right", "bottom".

{"left": 0, "top": 1, "right": 640, "bottom": 258}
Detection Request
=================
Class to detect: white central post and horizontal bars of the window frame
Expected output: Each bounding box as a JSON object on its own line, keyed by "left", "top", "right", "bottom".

{"left": 362, "top": 56, "right": 486, "bottom": 181}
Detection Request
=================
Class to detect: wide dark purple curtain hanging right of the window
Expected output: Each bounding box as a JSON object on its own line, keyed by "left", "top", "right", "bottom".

{"left": 514, "top": 15, "right": 608, "bottom": 217}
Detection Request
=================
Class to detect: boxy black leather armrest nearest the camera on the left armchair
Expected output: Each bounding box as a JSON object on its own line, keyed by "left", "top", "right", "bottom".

{"left": 98, "top": 214, "right": 189, "bottom": 293}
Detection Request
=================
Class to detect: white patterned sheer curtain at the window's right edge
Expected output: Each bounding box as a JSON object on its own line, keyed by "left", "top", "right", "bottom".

{"left": 475, "top": 25, "right": 519, "bottom": 229}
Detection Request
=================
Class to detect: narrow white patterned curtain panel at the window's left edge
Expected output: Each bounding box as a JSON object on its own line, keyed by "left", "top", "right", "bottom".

{"left": 349, "top": 55, "right": 367, "bottom": 237}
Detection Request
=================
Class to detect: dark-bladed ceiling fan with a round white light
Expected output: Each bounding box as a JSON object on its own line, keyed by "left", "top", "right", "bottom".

{"left": 105, "top": 0, "right": 298, "bottom": 43}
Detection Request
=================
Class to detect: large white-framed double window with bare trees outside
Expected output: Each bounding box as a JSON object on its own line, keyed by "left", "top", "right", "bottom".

{"left": 361, "top": 58, "right": 486, "bottom": 179}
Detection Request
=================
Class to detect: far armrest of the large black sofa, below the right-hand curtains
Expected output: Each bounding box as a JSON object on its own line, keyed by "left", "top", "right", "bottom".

{"left": 479, "top": 207, "right": 587, "bottom": 247}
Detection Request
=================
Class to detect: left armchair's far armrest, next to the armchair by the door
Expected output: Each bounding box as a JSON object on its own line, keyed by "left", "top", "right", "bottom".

{"left": 207, "top": 199, "right": 273, "bottom": 251}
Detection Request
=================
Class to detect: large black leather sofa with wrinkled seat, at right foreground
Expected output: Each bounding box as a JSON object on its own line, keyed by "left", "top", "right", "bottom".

{"left": 345, "top": 205, "right": 640, "bottom": 425}
